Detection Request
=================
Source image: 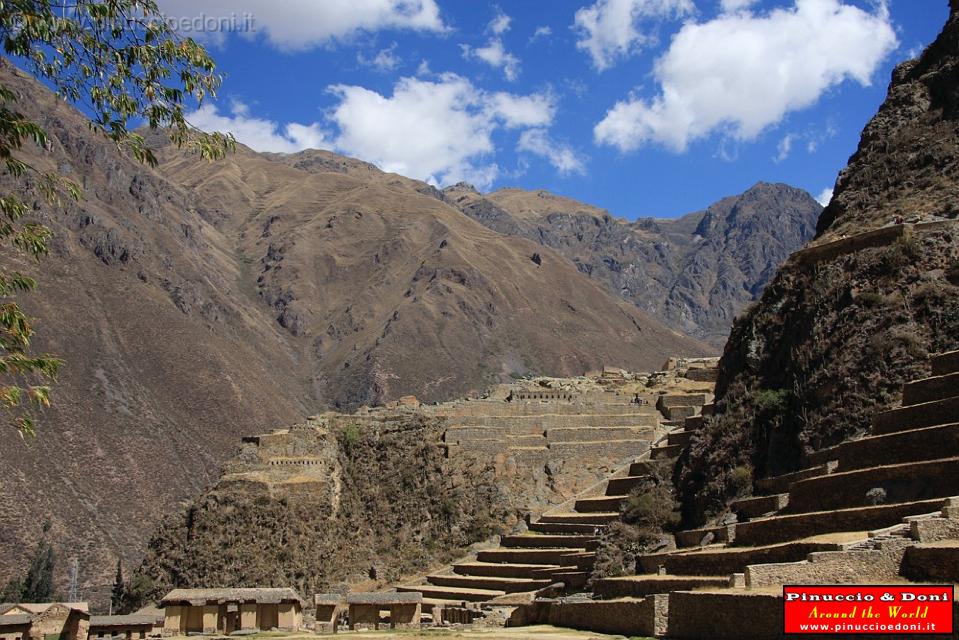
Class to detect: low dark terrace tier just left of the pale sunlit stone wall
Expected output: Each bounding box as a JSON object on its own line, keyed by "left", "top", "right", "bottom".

{"left": 637, "top": 536, "right": 868, "bottom": 576}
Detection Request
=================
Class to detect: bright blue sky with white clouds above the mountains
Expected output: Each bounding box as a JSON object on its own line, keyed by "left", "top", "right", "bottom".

{"left": 154, "top": 0, "right": 948, "bottom": 219}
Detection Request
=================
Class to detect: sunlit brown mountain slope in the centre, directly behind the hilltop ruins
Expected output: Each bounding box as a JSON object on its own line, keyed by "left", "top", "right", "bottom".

{"left": 152, "top": 142, "right": 708, "bottom": 407}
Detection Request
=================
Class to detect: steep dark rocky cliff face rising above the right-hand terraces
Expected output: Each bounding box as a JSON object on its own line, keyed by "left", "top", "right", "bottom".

{"left": 680, "top": 2, "right": 959, "bottom": 524}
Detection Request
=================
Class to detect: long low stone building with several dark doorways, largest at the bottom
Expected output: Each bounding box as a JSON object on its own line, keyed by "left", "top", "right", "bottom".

{"left": 160, "top": 588, "right": 303, "bottom": 635}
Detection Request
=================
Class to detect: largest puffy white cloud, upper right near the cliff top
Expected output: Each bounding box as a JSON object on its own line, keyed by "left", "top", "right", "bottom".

{"left": 593, "top": 0, "right": 898, "bottom": 151}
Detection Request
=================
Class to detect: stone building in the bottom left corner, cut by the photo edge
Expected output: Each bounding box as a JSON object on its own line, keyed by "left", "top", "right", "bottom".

{"left": 0, "top": 602, "right": 90, "bottom": 640}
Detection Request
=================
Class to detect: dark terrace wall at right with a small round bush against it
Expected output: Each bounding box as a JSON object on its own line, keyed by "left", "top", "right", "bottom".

{"left": 785, "top": 457, "right": 959, "bottom": 524}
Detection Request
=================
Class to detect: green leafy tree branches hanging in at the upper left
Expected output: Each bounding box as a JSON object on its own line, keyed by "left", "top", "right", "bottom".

{"left": 0, "top": 0, "right": 235, "bottom": 435}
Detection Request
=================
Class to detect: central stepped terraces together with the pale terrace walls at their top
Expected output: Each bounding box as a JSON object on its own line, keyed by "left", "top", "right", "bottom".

{"left": 397, "top": 361, "right": 715, "bottom": 608}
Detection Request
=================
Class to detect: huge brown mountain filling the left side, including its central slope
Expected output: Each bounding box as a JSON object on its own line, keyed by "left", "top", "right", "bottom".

{"left": 0, "top": 57, "right": 711, "bottom": 604}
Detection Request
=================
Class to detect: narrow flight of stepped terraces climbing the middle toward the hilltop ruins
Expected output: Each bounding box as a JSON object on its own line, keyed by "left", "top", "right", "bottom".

{"left": 396, "top": 394, "right": 707, "bottom": 608}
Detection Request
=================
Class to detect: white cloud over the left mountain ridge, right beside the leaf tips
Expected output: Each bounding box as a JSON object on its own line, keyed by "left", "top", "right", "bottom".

{"left": 186, "top": 102, "right": 333, "bottom": 153}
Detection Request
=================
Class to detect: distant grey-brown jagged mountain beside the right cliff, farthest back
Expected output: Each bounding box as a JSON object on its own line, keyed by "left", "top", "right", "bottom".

{"left": 445, "top": 182, "right": 822, "bottom": 347}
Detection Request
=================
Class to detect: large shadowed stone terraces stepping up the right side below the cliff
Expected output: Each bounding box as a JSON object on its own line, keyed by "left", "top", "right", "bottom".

{"left": 517, "top": 351, "right": 959, "bottom": 638}
